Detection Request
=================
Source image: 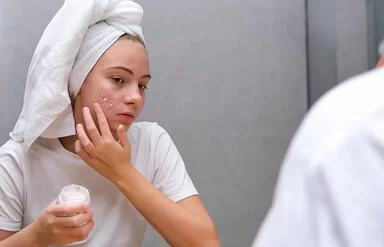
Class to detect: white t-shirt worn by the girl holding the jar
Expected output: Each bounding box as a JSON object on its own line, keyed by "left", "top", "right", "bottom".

{"left": 0, "top": 122, "right": 197, "bottom": 247}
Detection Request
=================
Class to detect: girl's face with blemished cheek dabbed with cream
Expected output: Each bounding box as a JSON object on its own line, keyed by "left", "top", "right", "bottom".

{"left": 74, "top": 38, "right": 151, "bottom": 135}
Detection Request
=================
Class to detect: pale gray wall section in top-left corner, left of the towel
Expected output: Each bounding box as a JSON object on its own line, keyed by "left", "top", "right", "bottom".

{"left": 0, "top": 0, "right": 59, "bottom": 143}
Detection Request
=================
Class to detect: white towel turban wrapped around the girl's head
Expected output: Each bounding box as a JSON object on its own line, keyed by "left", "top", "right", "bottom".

{"left": 10, "top": 0, "right": 144, "bottom": 150}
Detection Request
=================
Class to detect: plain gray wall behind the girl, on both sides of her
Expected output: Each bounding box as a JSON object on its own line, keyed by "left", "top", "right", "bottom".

{"left": 0, "top": 0, "right": 307, "bottom": 247}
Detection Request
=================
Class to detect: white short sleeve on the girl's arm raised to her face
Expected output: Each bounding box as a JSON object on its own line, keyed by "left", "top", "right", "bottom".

{"left": 152, "top": 124, "right": 198, "bottom": 202}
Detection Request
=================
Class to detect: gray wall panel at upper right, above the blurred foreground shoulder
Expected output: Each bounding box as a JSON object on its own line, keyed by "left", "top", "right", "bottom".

{"left": 307, "top": 0, "right": 372, "bottom": 104}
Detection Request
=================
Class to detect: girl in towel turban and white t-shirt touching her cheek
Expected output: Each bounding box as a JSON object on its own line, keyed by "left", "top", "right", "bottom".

{"left": 0, "top": 0, "right": 219, "bottom": 247}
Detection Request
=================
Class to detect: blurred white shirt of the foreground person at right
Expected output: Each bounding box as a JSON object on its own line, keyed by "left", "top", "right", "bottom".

{"left": 253, "top": 69, "right": 384, "bottom": 247}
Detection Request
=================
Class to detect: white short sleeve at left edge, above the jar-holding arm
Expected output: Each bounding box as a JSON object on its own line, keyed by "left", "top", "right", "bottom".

{"left": 0, "top": 147, "right": 23, "bottom": 231}
